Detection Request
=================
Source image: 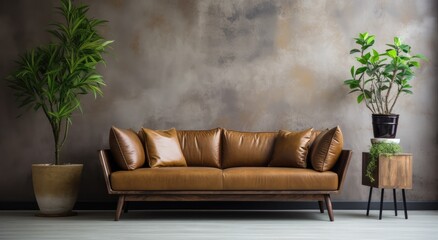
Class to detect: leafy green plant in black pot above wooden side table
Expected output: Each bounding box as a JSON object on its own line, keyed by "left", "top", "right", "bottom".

{"left": 344, "top": 32, "right": 426, "bottom": 138}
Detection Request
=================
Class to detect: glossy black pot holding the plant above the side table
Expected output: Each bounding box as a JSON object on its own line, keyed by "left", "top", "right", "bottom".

{"left": 373, "top": 114, "right": 398, "bottom": 138}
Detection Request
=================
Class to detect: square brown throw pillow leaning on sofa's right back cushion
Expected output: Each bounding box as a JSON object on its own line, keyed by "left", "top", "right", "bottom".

{"left": 269, "top": 128, "right": 312, "bottom": 168}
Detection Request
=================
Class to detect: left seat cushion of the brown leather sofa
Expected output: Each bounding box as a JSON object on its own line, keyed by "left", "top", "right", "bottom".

{"left": 111, "top": 167, "right": 222, "bottom": 191}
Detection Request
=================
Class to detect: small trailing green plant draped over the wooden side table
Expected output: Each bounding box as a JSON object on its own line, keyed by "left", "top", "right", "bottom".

{"left": 365, "top": 142, "right": 402, "bottom": 182}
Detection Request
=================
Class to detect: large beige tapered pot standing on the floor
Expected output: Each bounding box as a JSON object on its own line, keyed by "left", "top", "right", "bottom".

{"left": 32, "top": 164, "right": 83, "bottom": 217}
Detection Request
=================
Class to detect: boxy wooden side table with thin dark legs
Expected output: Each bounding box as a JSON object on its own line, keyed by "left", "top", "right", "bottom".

{"left": 362, "top": 152, "right": 412, "bottom": 220}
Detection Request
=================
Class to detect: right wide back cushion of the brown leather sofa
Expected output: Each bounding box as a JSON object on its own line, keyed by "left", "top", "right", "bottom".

{"left": 222, "top": 130, "right": 277, "bottom": 168}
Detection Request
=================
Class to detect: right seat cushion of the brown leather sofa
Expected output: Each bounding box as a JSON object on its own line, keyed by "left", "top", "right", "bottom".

{"left": 223, "top": 167, "right": 338, "bottom": 190}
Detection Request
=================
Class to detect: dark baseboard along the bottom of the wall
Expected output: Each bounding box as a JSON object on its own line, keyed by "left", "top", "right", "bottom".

{"left": 0, "top": 201, "right": 438, "bottom": 210}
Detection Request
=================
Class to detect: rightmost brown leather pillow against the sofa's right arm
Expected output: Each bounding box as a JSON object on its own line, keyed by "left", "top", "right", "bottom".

{"left": 310, "top": 126, "right": 344, "bottom": 172}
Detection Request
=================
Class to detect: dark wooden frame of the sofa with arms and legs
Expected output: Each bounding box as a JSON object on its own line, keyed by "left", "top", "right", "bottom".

{"left": 99, "top": 149, "right": 352, "bottom": 221}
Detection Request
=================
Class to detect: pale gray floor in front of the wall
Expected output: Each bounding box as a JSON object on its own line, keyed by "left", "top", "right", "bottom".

{"left": 0, "top": 210, "right": 438, "bottom": 240}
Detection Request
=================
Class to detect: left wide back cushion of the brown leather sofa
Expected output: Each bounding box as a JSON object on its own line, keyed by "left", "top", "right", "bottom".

{"left": 177, "top": 128, "right": 222, "bottom": 168}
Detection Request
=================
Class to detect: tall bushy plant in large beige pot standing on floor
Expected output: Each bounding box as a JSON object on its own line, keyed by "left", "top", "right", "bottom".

{"left": 7, "top": 0, "right": 112, "bottom": 216}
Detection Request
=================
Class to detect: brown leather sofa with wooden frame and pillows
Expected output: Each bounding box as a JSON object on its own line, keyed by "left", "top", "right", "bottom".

{"left": 99, "top": 127, "right": 352, "bottom": 221}
